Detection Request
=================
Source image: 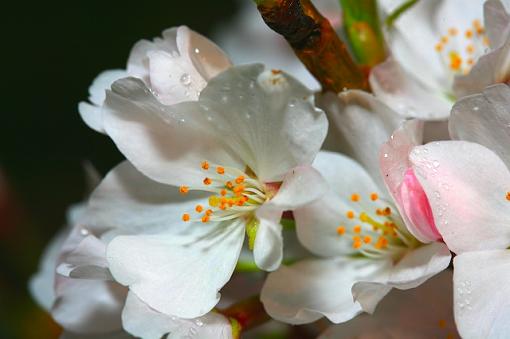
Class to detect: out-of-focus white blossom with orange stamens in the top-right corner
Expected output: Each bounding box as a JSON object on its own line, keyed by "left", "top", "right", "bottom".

{"left": 370, "top": 0, "right": 510, "bottom": 120}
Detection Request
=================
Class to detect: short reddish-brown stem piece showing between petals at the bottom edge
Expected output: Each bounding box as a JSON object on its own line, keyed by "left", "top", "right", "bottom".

{"left": 219, "top": 295, "right": 271, "bottom": 339}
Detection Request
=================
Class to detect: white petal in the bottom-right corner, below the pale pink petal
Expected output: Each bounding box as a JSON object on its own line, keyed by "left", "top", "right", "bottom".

{"left": 453, "top": 249, "right": 510, "bottom": 339}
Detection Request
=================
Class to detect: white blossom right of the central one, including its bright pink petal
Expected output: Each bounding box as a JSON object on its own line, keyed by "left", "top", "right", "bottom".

{"left": 261, "top": 91, "right": 450, "bottom": 324}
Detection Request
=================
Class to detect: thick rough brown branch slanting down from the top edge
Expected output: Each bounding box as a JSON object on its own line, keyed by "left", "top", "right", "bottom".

{"left": 255, "top": 0, "right": 369, "bottom": 93}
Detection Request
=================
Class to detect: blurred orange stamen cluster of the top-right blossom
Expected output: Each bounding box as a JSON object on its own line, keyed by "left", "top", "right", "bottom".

{"left": 435, "top": 20, "right": 489, "bottom": 75}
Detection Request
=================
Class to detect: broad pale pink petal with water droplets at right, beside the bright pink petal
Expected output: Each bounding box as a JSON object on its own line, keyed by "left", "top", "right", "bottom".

{"left": 410, "top": 141, "right": 510, "bottom": 254}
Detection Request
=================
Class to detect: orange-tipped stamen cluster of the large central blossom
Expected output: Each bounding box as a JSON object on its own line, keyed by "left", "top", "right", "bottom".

{"left": 179, "top": 161, "right": 270, "bottom": 223}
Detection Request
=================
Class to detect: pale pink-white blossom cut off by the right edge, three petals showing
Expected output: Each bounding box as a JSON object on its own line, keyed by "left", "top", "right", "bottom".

{"left": 411, "top": 84, "right": 510, "bottom": 339}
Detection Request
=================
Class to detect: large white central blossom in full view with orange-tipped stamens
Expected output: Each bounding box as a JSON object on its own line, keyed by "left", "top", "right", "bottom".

{"left": 87, "top": 65, "right": 327, "bottom": 318}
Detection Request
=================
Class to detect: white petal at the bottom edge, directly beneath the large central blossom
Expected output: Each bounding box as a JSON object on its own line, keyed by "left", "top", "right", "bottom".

{"left": 122, "top": 292, "right": 232, "bottom": 339}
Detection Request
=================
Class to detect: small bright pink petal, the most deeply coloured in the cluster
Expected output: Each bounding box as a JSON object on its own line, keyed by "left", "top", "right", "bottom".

{"left": 400, "top": 168, "right": 441, "bottom": 242}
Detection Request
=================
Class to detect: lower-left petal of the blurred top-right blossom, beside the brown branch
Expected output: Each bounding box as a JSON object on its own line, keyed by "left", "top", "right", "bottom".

{"left": 370, "top": 58, "right": 452, "bottom": 120}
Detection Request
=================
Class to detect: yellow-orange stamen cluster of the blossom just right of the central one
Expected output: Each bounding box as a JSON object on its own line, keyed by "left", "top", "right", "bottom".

{"left": 336, "top": 193, "right": 418, "bottom": 260}
